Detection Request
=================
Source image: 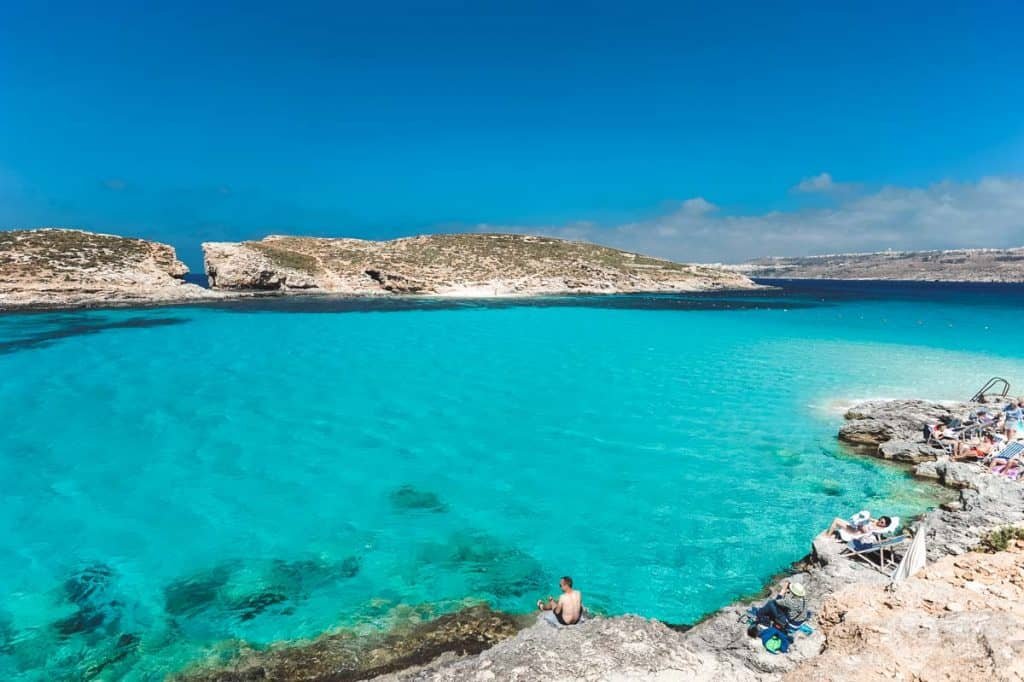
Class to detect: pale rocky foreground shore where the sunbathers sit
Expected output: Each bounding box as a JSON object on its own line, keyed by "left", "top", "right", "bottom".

{"left": 183, "top": 400, "right": 1024, "bottom": 682}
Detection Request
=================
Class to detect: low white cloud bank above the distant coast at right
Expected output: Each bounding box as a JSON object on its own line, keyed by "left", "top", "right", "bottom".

{"left": 480, "top": 177, "right": 1024, "bottom": 262}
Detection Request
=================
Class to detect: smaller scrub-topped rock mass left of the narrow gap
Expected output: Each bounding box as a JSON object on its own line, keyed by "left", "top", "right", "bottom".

{"left": 0, "top": 228, "right": 217, "bottom": 309}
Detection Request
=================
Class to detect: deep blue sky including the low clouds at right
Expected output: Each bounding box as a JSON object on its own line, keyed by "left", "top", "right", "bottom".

{"left": 0, "top": 0, "right": 1024, "bottom": 268}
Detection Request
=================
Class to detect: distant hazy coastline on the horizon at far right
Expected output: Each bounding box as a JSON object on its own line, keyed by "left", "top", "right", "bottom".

{"left": 729, "top": 248, "right": 1024, "bottom": 282}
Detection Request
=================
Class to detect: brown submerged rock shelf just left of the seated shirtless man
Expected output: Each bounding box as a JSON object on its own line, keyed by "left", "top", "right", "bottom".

{"left": 175, "top": 605, "right": 532, "bottom": 682}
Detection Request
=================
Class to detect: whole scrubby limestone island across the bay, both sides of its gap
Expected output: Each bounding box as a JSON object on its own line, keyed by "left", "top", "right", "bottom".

{"left": 0, "top": 228, "right": 757, "bottom": 309}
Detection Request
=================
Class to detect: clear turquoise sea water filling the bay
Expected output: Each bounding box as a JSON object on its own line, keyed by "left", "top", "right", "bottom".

{"left": 0, "top": 284, "right": 1024, "bottom": 679}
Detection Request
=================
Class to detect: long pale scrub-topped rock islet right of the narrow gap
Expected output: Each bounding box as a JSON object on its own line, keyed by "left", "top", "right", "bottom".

{"left": 203, "top": 233, "right": 757, "bottom": 297}
